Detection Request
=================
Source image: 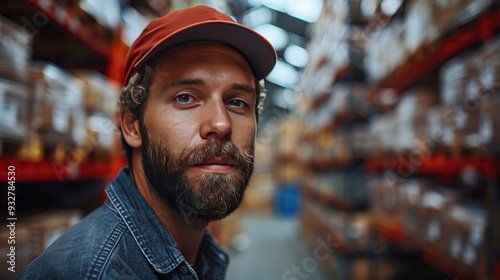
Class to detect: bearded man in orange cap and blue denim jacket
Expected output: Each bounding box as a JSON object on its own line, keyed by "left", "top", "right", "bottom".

{"left": 20, "top": 6, "right": 276, "bottom": 279}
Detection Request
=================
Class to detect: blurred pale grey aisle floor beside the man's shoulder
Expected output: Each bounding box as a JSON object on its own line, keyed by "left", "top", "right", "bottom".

{"left": 227, "top": 213, "right": 331, "bottom": 280}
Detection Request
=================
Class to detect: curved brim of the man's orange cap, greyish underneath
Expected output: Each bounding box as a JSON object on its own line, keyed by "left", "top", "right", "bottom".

{"left": 134, "top": 21, "right": 276, "bottom": 80}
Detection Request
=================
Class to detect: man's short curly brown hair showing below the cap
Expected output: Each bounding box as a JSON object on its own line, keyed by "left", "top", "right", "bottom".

{"left": 118, "top": 59, "right": 266, "bottom": 166}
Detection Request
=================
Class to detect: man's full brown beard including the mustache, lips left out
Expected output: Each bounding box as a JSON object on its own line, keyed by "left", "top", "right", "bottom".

{"left": 141, "top": 123, "right": 254, "bottom": 227}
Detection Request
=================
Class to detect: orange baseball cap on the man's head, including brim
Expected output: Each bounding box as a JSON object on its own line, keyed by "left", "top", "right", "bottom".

{"left": 123, "top": 5, "right": 276, "bottom": 85}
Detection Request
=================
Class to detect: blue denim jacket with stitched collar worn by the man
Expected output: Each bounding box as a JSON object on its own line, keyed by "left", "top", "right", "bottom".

{"left": 19, "top": 168, "right": 229, "bottom": 280}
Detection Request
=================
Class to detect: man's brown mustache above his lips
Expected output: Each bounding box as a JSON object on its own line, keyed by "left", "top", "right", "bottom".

{"left": 179, "top": 139, "right": 254, "bottom": 169}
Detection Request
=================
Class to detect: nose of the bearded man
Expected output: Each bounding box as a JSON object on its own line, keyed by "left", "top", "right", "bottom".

{"left": 200, "top": 100, "right": 232, "bottom": 139}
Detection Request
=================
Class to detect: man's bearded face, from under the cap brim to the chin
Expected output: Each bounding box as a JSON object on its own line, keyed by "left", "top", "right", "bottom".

{"left": 140, "top": 43, "right": 257, "bottom": 222}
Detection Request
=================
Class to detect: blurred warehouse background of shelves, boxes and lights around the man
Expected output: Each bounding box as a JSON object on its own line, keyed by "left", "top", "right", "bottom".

{"left": 0, "top": 0, "right": 500, "bottom": 280}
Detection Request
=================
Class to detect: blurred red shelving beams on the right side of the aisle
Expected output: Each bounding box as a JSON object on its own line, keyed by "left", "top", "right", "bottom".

{"left": 301, "top": 1, "right": 500, "bottom": 279}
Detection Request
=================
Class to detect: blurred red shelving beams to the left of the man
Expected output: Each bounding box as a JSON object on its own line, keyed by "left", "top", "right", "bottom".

{"left": 0, "top": 0, "right": 126, "bottom": 183}
